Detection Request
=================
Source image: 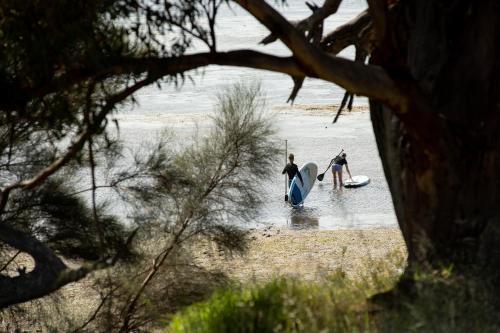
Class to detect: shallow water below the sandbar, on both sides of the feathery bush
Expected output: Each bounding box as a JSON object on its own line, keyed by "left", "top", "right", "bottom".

{"left": 116, "top": 108, "right": 396, "bottom": 229}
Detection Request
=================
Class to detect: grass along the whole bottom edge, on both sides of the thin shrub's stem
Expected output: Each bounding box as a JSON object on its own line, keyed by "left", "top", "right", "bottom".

{"left": 4, "top": 228, "right": 500, "bottom": 333}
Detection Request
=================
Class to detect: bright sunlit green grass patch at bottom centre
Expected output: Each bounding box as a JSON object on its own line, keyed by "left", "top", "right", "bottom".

{"left": 168, "top": 271, "right": 395, "bottom": 333}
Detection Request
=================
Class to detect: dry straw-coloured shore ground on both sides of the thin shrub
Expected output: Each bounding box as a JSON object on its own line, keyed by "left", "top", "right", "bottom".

{"left": 0, "top": 227, "right": 406, "bottom": 332}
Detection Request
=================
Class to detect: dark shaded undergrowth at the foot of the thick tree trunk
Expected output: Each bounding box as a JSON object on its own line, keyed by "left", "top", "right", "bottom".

{"left": 376, "top": 266, "right": 500, "bottom": 333}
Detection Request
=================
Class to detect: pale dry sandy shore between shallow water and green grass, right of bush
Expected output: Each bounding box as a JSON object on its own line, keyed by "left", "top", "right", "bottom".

{"left": 195, "top": 227, "right": 406, "bottom": 282}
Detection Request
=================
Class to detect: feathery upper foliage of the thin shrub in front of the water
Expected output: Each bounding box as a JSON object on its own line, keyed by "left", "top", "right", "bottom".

{"left": 120, "top": 83, "right": 280, "bottom": 239}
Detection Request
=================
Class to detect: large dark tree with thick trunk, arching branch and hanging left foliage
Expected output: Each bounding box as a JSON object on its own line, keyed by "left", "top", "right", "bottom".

{"left": 0, "top": 0, "right": 500, "bottom": 322}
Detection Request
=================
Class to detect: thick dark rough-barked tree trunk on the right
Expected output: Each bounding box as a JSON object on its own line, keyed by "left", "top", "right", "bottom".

{"left": 370, "top": 0, "right": 500, "bottom": 273}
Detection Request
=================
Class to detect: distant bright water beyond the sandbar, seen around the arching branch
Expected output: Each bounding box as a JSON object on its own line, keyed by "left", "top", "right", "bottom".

{"left": 122, "top": 0, "right": 367, "bottom": 116}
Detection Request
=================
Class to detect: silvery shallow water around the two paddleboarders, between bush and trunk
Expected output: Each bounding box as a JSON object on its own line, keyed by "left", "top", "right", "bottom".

{"left": 261, "top": 112, "right": 396, "bottom": 229}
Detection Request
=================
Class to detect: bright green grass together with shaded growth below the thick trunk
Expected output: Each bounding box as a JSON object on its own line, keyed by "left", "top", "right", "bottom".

{"left": 166, "top": 263, "right": 500, "bottom": 333}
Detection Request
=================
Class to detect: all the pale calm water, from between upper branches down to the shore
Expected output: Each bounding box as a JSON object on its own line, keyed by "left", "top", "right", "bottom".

{"left": 114, "top": 0, "right": 396, "bottom": 229}
